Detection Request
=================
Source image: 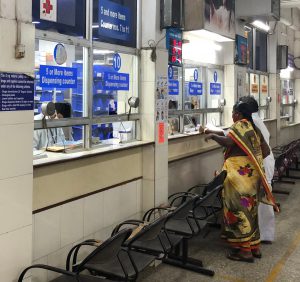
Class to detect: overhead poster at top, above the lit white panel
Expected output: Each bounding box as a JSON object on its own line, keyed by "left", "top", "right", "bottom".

{"left": 204, "top": 0, "right": 235, "bottom": 39}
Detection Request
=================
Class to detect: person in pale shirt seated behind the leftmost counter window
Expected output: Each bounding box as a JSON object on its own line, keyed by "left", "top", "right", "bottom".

{"left": 33, "top": 102, "right": 66, "bottom": 150}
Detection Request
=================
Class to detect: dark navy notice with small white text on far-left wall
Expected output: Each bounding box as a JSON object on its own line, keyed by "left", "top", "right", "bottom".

{"left": 0, "top": 72, "right": 34, "bottom": 111}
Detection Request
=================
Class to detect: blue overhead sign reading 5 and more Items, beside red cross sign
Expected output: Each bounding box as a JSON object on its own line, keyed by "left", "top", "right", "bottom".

{"left": 99, "top": 0, "right": 134, "bottom": 41}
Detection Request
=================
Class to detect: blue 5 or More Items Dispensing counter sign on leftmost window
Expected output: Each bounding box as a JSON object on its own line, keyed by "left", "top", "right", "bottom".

{"left": 40, "top": 65, "right": 77, "bottom": 89}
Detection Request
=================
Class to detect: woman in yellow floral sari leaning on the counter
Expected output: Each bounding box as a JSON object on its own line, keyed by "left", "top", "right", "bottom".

{"left": 206, "top": 102, "right": 275, "bottom": 262}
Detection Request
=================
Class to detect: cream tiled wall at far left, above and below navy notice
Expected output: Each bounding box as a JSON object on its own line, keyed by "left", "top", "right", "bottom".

{"left": 0, "top": 0, "right": 34, "bottom": 282}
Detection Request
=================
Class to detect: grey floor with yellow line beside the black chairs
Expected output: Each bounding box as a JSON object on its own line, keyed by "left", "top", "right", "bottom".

{"left": 139, "top": 174, "right": 300, "bottom": 282}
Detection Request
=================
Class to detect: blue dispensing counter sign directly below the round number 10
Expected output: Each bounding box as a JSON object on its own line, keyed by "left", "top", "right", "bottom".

{"left": 102, "top": 72, "right": 129, "bottom": 91}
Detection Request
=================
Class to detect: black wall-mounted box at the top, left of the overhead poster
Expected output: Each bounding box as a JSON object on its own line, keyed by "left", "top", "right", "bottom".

{"left": 160, "top": 0, "right": 184, "bottom": 29}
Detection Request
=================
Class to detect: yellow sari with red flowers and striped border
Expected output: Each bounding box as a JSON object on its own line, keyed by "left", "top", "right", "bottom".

{"left": 223, "top": 119, "right": 276, "bottom": 251}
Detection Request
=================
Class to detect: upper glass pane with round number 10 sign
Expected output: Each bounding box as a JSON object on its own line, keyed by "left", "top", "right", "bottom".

{"left": 93, "top": 49, "right": 138, "bottom": 116}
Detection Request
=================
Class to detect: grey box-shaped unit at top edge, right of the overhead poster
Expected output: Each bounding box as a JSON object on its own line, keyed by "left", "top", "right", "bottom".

{"left": 235, "top": 0, "right": 280, "bottom": 21}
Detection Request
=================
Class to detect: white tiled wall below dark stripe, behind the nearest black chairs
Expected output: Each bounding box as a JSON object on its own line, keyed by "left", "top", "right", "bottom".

{"left": 33, "top": 180, "right": 142, "bottom": 282}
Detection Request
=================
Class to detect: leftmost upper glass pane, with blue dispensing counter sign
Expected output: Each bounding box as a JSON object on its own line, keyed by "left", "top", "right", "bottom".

{"left": 34, "top": 40, "right": 85, "bottom": 119}
